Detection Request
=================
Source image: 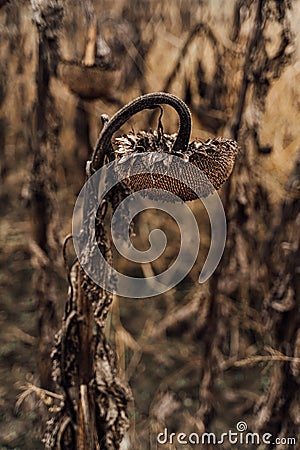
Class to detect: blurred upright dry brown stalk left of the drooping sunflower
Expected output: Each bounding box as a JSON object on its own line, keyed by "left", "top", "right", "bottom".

{"left": 30, "top": 0, "right": 63, "bottom": 389}
